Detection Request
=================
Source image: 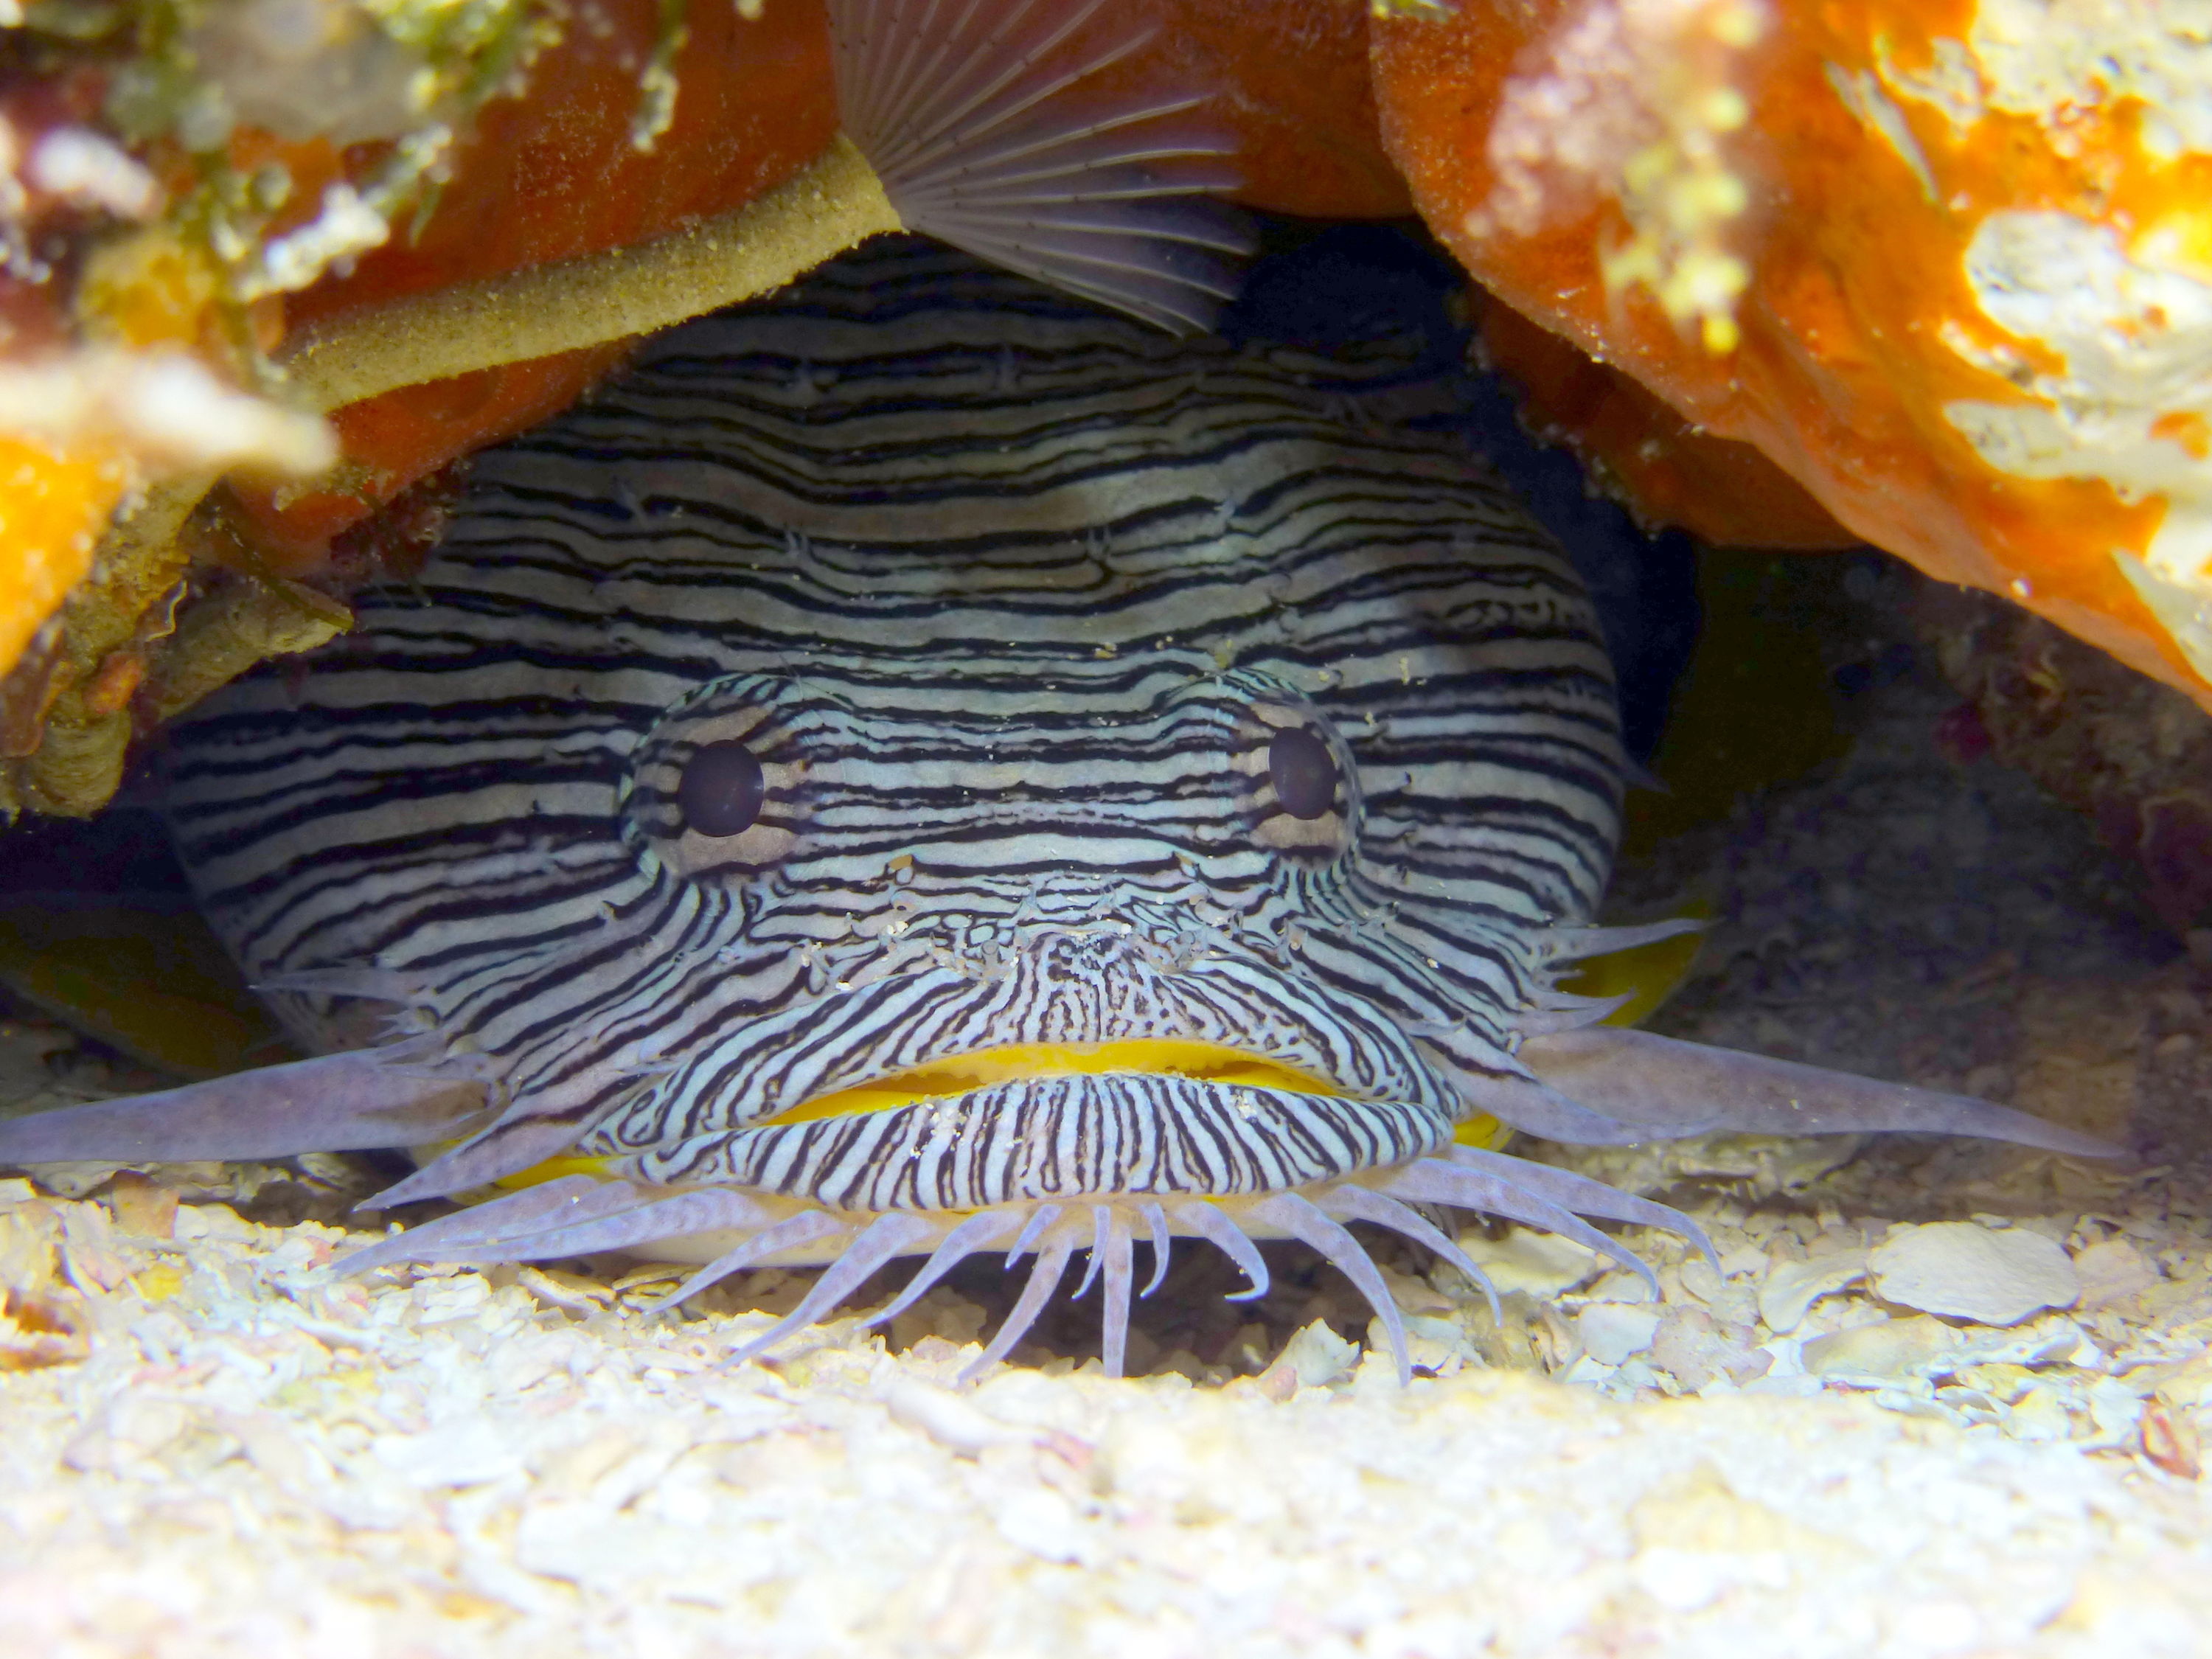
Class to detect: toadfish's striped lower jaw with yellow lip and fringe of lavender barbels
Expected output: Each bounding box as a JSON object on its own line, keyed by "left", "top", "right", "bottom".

{"left": 345, "top": 1037, "right": 1710, "bottom": 1378}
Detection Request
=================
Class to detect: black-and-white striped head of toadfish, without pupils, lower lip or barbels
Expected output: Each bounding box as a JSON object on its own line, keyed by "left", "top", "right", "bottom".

{"left": 170, "top": 241, "right": 1621, "bottom": 1203}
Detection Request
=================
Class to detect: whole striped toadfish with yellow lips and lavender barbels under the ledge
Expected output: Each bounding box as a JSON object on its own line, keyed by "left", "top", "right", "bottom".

{"left": 0, "top": 0, "right": 2112, "bottom": 1374}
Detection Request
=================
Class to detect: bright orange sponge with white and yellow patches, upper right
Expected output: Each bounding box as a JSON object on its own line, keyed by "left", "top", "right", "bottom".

{"left": 1374, "top": 0, "right": 2212, "bottom": 703}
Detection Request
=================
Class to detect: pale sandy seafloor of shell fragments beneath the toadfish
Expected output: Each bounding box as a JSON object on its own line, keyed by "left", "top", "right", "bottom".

{"left": 0, "top": 566, "right": 2212, "bottom": 1659}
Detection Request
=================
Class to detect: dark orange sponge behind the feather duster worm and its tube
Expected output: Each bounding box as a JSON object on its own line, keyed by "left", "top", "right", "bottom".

{"left": 220, "top": 0, "right": 1411, "bottom": 575}
